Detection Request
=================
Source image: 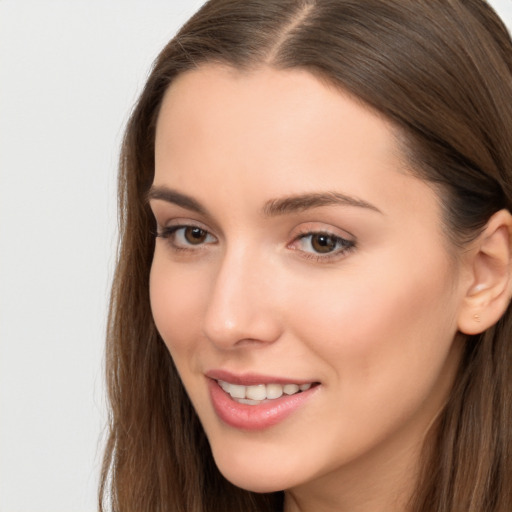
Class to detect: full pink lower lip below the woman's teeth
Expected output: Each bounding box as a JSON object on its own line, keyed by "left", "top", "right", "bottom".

{"left": 208, "top": 379, "right": 319, "bottom": 430}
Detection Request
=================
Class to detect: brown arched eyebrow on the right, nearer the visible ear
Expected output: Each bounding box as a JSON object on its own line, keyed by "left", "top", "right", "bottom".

{"left": 263, "top": 192, "right": 382, "bottom": 217}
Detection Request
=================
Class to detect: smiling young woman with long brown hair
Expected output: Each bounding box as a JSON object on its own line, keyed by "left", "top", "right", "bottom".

{"left": 100, "top": 0, "right": 512, "bottom": 512}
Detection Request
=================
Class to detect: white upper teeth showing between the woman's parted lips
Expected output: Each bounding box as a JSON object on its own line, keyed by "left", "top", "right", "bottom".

{"left": 217, "top": 380, "right": 316, "bottom": 405}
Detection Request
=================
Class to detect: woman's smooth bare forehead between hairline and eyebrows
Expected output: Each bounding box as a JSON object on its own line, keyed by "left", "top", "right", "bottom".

{"left": 154, "top": 65, "right": 441, "bottom": 243}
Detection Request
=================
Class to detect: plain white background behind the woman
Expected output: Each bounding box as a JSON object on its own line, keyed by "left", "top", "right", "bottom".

{"left": 0, "top": 0, "right": 512, "bottom": 512}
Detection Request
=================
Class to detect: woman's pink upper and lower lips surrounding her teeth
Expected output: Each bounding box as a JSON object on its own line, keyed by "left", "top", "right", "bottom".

{"left": 207, "top": 371, "right": 320, "bottom": 431}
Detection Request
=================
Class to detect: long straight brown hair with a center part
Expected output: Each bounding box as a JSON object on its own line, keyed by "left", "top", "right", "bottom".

{"left": 100, "top": 0, "right": 512, "bottom": 512}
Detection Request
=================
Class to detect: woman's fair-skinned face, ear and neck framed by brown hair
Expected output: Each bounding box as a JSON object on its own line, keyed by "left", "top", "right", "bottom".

{"left": 149, "top": 65, "right": 510, "bottom": 512}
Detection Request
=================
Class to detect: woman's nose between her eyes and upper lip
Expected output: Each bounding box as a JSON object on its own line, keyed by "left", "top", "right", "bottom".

{"left": 202, "top": 246, "right": 281, "bottom": 350}
